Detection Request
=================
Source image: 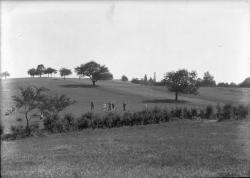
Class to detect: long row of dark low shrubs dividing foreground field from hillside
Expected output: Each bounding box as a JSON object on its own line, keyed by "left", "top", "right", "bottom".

{"left": 2, "top": 104, "right": 248, "bottom": 139}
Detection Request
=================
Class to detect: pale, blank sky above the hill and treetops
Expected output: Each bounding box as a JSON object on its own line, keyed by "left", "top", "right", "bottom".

{"left": 1, "top": 0, "right": 250, "bottom": 83}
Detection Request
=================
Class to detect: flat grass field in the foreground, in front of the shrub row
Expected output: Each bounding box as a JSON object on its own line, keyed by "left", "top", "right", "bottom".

{"left": 2, "top": 120, "right": 250, "bottom": 178}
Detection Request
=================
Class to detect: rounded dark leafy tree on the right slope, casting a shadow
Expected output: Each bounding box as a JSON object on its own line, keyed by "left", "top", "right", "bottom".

{"left": 165, "top": 69, "right": 198, "bottom": 101}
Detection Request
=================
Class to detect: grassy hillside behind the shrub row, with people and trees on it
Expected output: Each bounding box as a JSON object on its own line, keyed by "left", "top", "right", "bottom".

{"left": 0, "top": 78, "right": 250, "bottom": 131}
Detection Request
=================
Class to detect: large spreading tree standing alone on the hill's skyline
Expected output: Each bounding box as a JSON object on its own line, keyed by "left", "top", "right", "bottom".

{"left": 75, "top": 61, "right": 113, "bottom": 86}
